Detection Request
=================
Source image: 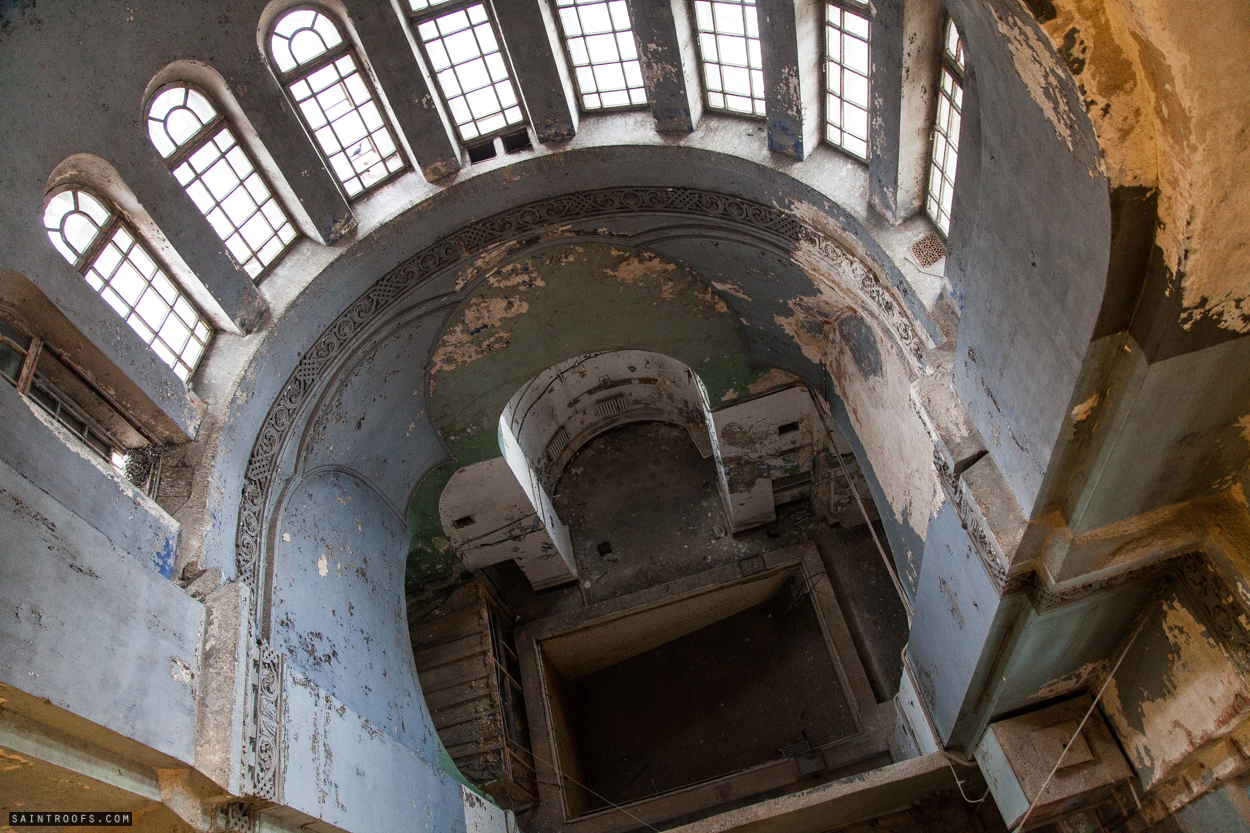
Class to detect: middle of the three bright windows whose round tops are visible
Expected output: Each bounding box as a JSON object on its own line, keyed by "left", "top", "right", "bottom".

{"left": 148, "top": 84, "right": 295, "bottom": 279}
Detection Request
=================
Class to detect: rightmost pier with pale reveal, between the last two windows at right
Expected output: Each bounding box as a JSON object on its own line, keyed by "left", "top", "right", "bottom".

{"left": 869, "top": 0, "right": 946, "bottom": 223}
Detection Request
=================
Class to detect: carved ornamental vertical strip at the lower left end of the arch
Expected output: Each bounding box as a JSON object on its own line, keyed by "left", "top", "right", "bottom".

{"left": 243, "top": 639, "right": 286, "bottom": 803}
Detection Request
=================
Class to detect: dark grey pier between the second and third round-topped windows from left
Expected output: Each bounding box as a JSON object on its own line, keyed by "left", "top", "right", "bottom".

{"left": 219, "top": 59, "right": 356, "bottom": 245}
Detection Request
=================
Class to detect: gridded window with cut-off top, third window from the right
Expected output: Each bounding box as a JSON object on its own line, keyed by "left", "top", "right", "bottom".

{"left": 695, "top": 0, "right": 764, "bottom": 116}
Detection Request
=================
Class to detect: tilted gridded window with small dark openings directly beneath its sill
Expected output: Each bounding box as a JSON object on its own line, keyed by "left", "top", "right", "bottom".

{"left": 413, "top": 3, "right": 525, "bottom": 141}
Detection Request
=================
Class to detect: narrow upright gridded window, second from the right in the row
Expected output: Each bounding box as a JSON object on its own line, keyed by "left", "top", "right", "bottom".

{"left": 825, "top": 3, "right": 871, "bottom": 160}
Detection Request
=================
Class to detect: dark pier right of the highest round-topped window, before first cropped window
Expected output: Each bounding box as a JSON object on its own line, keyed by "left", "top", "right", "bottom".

{"left": 351, "top": 3, "right": 460, "bottom": 183}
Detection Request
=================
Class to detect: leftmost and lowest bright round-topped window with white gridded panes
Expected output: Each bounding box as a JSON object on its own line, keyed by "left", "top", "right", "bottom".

{"left": 44, "top": 188, "right": 213, "bottom": 381}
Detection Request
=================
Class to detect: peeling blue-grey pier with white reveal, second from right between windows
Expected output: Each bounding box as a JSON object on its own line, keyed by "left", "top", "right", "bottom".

{"left": 756, "top": 0, "right": 825, "bottom": 160}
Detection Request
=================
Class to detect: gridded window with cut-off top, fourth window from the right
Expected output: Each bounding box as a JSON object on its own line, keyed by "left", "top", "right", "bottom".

{"left": 556, "top": 0, "right": 646, "bottom": 110}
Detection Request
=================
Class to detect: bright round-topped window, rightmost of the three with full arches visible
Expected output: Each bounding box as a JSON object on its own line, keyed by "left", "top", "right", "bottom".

{"left": 269, "top": 9, "right": 405, "bottom": 196}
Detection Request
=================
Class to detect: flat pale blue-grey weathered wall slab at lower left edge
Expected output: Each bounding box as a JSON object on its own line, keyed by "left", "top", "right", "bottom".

{"left": 0, "top": 450, "right": 204, "bottom": 765}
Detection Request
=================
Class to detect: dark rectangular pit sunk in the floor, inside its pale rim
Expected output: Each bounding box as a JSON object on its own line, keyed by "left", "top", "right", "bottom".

{"left": 561, "top": 597, "right": 859, "bottom": 812}
